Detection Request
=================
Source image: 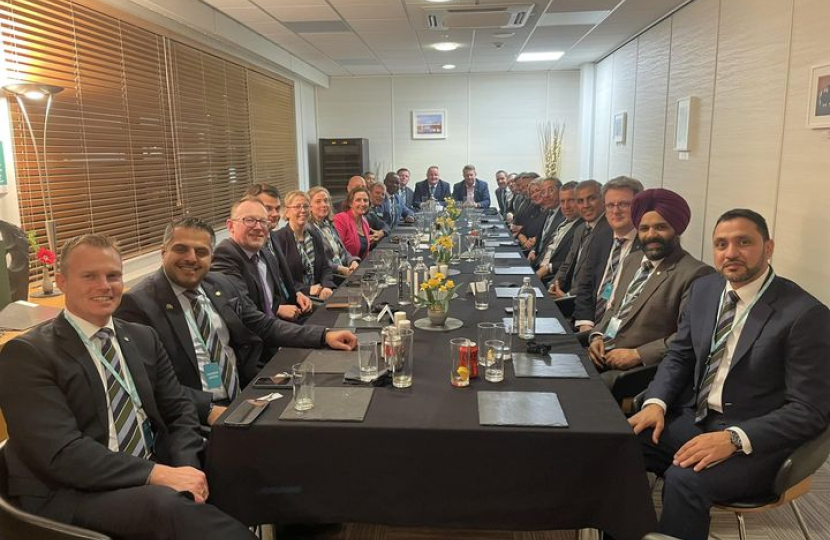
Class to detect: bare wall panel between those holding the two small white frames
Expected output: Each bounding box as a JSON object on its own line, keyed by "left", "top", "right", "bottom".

{"left": 631, "top": 20, "right": 671, "bottom": 187}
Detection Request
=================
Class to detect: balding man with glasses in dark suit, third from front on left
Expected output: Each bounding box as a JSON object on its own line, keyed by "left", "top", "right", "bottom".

{"left": 211, "top": 197, "right": 312, "bottom": 321}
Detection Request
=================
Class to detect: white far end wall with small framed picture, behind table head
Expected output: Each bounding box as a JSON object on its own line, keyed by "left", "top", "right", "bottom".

{"left": 317, "top": 71, "right": 580, "bottom": 199}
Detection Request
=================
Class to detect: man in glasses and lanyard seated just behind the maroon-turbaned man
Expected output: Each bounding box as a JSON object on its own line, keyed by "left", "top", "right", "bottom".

{"left": 573, "top": 176, "right": 643, "bottom": 332}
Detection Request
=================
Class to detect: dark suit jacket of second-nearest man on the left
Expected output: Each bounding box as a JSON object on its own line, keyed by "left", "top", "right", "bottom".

{"left": 116, "top": 268, "right": 325, "bottom": 423}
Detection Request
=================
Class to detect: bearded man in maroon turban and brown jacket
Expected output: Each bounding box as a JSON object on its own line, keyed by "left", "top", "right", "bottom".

{"left": 588, "top": 188, "right": 714, "bottom": 381}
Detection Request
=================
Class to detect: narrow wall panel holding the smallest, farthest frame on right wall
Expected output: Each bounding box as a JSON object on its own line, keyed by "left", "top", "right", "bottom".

{"left": 608, "top": 40, "right": 637, "bottom": 178}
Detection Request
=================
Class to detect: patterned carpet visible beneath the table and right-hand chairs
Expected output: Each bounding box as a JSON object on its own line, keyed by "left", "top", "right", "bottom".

{"left": 276, "top": 461, "right": 830, "bottom": 540}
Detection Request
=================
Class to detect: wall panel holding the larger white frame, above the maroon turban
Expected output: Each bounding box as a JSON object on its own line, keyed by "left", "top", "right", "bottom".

{"left": 663, "top": 0, "right": 719, "bottom": 257}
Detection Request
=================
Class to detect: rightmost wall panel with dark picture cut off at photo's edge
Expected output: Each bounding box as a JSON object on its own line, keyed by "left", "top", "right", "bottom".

{"left": 773, "top": 0, "right": 830, "bottom": 304}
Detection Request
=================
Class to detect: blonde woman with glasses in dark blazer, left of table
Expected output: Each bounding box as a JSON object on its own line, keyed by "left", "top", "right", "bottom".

{"left": 275, "top": 191, "right": 336, "bottom": 300}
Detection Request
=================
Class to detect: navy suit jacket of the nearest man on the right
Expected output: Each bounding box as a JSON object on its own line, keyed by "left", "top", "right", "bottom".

{"left": 646, "top": 274, "right": 830, "bottom": 455}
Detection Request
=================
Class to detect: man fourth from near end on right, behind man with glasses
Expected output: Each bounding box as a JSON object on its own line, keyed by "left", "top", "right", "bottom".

{"left": 548, "top": 180, "right": 608, "bottom": 298}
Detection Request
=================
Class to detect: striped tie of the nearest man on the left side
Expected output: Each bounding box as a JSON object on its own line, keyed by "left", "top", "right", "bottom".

{"left": 95, "top": 328, "right": 147, "bottom": 458}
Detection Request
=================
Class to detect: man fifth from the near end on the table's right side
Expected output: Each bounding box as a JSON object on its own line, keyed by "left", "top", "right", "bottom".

{"left": 528, "top": 182, "right": 582, "bottom": 281}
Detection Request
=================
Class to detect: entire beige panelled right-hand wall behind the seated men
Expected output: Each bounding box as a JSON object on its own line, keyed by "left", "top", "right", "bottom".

{"left": 593, "top": 0, "right": 830, "bottom": 303}
